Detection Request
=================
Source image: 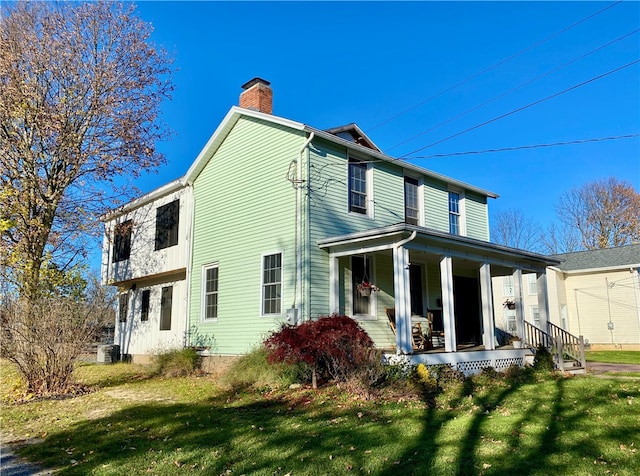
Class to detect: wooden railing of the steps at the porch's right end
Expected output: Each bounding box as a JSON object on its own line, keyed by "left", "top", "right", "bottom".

{"left": 523, "top": 321, "right": 587, "bottom": 371}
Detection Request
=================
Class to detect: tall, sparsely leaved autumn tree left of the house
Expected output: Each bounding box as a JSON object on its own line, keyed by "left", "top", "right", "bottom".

{"left": 0, "top": 2, "right": 172, "bottom": 302}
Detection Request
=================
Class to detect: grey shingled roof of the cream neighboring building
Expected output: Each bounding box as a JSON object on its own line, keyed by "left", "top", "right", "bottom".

{"left": 552, "top": 244, "right": 640, "bottom": 271}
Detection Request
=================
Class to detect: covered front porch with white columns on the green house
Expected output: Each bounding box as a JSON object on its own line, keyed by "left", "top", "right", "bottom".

{"left": 319, "top": 223, "right": 557, "bottom": 368}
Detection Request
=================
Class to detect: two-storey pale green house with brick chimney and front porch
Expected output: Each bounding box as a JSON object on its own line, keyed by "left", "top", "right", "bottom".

{"left": 102, "top": 78, "right": 558, "bottom": 372}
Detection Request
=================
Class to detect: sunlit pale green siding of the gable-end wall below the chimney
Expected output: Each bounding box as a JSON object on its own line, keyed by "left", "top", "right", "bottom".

{"left": 190, "top": 118, "right": 304, "bottom": 354}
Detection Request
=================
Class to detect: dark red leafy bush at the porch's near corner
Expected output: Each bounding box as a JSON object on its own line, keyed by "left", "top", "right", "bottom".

{"left": 264, "top": 315, "right": 375, "bottom": 388}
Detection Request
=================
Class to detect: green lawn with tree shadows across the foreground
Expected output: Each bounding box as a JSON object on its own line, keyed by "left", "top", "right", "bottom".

{"left": 0, "top": 362, "right": 640, "bottom": 475}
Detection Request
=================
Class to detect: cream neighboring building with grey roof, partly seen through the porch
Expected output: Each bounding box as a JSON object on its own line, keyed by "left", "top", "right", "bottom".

{"left": 493, "top": 244, "right": 640, "bottom": 350}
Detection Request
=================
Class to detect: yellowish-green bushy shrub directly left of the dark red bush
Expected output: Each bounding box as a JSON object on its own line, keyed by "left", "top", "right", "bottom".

{"left": 220, "top": 347, "right": 306, "bottom": 391}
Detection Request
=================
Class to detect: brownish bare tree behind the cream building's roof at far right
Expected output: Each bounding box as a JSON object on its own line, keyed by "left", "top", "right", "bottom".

{"left": 556, "top": 177, "right": 640, "bottom": 250}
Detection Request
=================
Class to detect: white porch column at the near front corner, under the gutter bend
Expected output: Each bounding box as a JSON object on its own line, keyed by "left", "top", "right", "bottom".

{"left": 393, "top": 246, "right": 413, "bottom": 354}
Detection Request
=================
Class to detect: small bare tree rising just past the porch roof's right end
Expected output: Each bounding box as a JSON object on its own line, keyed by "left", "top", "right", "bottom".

{"left": 491, "top": 208, "right": 542, "bottom": 252}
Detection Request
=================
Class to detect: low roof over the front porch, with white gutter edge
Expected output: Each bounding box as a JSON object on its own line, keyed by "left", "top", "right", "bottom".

{"left": 318, "top": 223, "right": 560, "bottom": 271}
